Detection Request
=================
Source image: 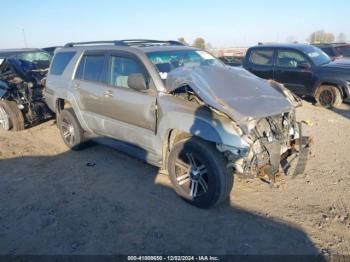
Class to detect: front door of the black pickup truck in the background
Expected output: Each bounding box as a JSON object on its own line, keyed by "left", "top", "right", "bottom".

{"left": 274, "top": 49, "right": 313, "bottom": 95}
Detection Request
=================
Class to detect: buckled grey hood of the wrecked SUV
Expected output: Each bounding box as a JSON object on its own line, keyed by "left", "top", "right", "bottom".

{"left": 166, "top": 66, "right": 294, "bottom": 122}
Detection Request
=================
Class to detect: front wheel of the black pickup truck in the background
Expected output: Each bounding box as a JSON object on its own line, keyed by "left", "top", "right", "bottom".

{"left": 315, "top": 85, "right": 343, "bottom": 108}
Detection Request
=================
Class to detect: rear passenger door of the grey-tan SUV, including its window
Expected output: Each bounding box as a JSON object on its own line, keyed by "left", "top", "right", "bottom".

{"left": 72, "top": 51, "right": 108, "bottom": 133}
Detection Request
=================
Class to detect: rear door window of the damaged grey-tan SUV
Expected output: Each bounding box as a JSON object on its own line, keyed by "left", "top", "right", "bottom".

{"left": 75, "top": 55, "right": 105, "bottom": 82}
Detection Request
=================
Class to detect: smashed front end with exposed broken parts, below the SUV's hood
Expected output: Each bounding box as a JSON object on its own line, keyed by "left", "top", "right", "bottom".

{"left": 220, "top": 110, "right": 309, "bottom": 182}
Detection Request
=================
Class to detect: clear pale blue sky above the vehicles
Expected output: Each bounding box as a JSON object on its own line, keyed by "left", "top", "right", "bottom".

{"left": 0, "top": 0, "right": 350, "bottom": 49}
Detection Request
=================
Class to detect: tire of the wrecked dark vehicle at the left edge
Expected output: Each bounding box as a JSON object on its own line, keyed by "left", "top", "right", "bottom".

{"left": 0, "top": 100, "right": 24, "bottom": 131}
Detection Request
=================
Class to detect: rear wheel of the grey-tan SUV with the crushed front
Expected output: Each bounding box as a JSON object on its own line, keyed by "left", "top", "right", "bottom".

{"left": 58, "top": 108, "right": 84, "bottom": 150}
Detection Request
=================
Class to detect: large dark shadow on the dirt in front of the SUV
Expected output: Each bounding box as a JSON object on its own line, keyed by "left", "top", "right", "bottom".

{"left": 0, "top": 145, "right": 327, "bottom": 261}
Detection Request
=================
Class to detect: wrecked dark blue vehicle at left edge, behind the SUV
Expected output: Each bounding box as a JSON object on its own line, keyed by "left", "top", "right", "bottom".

{"left": 0, "top": 49, "right": 52, "bottom": 131}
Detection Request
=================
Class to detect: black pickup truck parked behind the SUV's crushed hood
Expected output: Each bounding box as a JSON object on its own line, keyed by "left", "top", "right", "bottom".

{"left": 243, "top": 44, "right": 350, "bottom": 107}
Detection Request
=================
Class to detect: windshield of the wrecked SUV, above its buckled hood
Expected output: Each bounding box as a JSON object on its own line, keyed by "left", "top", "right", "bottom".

{"left": 147, "top": 50, "right": 223, "bottom": 79}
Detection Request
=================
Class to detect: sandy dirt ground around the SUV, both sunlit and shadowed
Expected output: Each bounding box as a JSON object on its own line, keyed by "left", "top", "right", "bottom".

{"left": 0, "top": 103, "right": 350, "bottom": 255}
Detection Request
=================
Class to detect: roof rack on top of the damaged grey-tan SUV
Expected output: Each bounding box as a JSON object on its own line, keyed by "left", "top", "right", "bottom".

{"left": 64, "top": 39, "right": 184, "bottom": 47}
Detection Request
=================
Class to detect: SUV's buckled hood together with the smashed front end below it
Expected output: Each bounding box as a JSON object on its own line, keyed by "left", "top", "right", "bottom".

{"left": 166, "top": 66, "right": 308, "bottom": 180}
